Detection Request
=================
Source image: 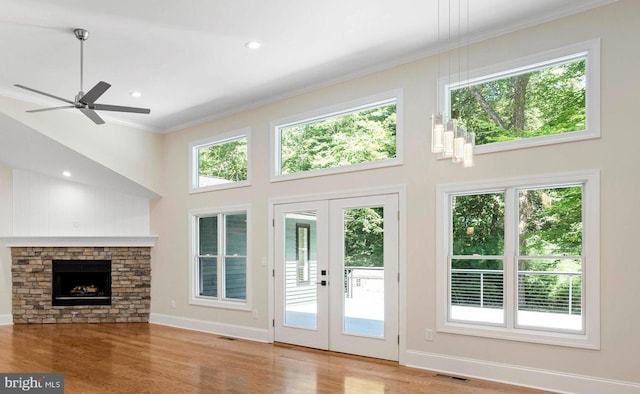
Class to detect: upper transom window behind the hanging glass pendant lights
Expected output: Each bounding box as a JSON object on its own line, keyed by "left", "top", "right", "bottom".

{"left": 440, "top": 41, "right": 600, "bottom": 153}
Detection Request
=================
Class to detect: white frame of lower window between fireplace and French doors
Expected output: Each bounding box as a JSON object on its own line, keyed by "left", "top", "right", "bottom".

{"left": 189, "top": 205, "right": 251, "bottom": 311}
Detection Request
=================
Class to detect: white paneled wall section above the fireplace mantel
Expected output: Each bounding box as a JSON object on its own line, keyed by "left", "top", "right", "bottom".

{"left": 11, "top": 170, "right": 149, "bottom": 236}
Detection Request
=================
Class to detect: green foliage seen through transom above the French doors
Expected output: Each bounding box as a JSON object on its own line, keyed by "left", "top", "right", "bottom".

{"left": 281, "top": 104, "right": 396, "bottom": 174}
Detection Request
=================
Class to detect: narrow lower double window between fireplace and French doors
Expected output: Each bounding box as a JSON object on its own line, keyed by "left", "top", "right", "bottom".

{"left": 190, "top": 208, "right": 248, "bottom": 307}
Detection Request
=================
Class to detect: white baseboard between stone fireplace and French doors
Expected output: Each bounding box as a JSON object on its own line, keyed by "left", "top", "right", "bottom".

{"left": 149, "top": 313, "right": 269, "bottom": 342}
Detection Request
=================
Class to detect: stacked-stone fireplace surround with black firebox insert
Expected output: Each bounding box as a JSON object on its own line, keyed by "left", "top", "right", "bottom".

{"left": 11, "top": 246, "right": 151, "bottom": 324}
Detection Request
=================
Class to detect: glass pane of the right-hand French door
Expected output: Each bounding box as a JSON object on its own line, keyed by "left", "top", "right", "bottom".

{"left": 343, "top": 207, "right": 385, "bottom": 337}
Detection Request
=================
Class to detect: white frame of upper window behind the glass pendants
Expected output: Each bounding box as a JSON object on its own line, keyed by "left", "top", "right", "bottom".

{"left": 438, "top": 39, "right": 600, "bottom": 155}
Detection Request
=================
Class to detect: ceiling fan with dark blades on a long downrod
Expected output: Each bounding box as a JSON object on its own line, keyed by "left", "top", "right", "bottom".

{"left": 14, "top": 29, "right": 151, "bottom": 124}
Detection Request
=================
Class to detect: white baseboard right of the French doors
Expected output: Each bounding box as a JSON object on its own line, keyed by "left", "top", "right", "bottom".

{"left": 402, "top": 350, "right": 640, "bottom": 394}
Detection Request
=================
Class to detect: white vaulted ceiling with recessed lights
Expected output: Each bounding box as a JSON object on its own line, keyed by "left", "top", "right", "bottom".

{"left": 0, "top": 0, "right": 614, "bottom": 132}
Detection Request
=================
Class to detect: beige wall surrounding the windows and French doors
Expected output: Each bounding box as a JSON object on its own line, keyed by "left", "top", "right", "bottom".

{"left": 152, "top": 0, "right": 640, "bottom": 392}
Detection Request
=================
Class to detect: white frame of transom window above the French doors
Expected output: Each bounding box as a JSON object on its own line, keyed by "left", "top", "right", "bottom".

{"left": 269, "top": 89, "right": 404, "bottom": 182}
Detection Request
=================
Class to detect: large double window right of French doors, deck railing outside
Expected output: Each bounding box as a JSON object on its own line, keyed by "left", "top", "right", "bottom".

{"left": 438, "top": 173, "right": 599, "bottom": 348}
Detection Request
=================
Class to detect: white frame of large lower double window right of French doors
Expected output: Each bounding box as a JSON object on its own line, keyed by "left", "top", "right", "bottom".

{"left": 436, "top": 170, "right": 600, "bottom": 349}
